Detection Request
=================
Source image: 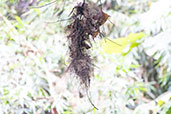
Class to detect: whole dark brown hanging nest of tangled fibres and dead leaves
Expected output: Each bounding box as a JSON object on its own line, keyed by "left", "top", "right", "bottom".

{"left": 67, "top": 1, "right": 109, "bottom": 88}
